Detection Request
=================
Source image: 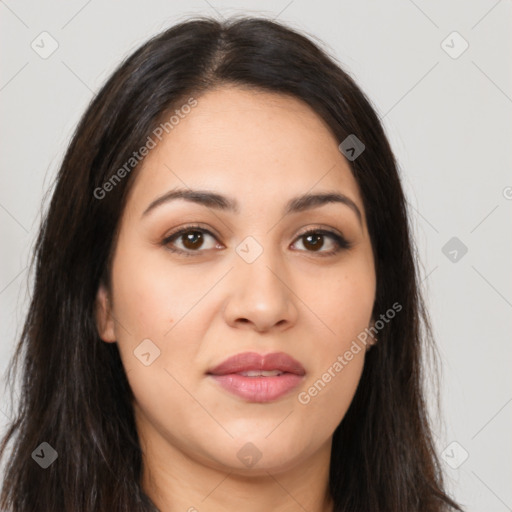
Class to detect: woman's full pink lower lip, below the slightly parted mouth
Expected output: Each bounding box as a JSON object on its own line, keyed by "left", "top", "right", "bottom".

{"left": 210, "top": 373, "right": 303, "bottom": 402}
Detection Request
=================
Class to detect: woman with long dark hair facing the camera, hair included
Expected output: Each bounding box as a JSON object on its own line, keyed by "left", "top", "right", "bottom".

{"left": 0, "top": 14, "right": 461, "bottom": 512}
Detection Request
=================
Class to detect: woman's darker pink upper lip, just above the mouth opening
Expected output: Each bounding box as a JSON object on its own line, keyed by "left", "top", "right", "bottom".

{"left": 208, "top": 352, "right": 306, "bottom": 375}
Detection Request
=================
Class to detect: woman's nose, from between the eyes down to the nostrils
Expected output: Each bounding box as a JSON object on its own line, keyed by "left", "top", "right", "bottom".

{"left": 224, "top": 244, "right": 298, "bottom": 332}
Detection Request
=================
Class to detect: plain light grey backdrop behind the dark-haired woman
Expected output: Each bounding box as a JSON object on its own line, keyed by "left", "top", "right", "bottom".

{"left": 0, "top": 0, "right": 512, "bottom": 512}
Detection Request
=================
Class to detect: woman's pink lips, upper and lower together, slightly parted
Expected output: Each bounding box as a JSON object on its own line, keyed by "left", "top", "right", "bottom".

{"left": 208, "top": 352, "right": 306, "bottom": 403}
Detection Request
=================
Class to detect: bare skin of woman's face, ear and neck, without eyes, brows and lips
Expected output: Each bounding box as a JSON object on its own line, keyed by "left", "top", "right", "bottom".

{"left": 97, "top": 86, "right": 376, "bottom": 512}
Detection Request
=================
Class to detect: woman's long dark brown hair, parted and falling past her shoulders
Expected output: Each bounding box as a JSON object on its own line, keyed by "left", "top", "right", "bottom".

{"left": 0, "top": 14, "right": 461, "bottom": 512}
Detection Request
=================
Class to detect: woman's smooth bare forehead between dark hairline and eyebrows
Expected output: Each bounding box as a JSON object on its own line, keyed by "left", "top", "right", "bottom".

{"left": 125, "top": 86, "right": 364, "bottom": 224}
